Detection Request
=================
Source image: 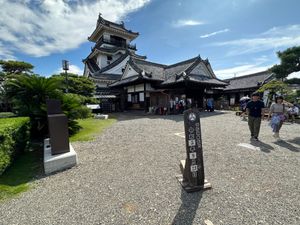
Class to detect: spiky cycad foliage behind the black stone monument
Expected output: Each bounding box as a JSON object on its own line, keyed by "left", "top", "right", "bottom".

{"left": 6, "top": 74, "right": 90, "bottom": 136}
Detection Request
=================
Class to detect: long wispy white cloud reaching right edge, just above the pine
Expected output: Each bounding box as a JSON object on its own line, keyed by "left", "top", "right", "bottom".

{"left": 213, "top": 24, "right": 300, "bottom": 56}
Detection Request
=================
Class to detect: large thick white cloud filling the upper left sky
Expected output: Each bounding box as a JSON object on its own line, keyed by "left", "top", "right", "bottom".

{"left": 0, "top": 0, "right": 150, "bottom": 57}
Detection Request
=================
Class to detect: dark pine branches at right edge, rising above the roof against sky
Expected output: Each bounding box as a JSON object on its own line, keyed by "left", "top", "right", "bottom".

{"left": 270, "top": 46, "right": 300, "bottom": 80}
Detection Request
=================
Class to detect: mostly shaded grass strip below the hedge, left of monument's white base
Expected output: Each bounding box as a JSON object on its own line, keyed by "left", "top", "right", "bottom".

{"left": 0, "top": 147, "right": 42, "bottom": 201}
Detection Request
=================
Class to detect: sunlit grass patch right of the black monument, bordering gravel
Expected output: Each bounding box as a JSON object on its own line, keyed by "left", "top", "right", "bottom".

{"left": 70, "top": 118, "right": 117, "bottom": 142}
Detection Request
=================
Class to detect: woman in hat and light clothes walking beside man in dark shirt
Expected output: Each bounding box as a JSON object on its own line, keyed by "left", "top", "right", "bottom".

{"left": 268, "top": 96, "right": 287, "bottom": 140}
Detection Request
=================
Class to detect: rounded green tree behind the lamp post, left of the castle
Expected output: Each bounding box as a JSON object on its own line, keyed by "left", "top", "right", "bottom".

{"left": 52, "top": 73, "right": 95, "bottom": 97}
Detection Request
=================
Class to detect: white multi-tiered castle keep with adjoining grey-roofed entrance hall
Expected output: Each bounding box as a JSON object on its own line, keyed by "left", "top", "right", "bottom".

{"left": 83, "top": 14, "right": 227, "bottom": 113}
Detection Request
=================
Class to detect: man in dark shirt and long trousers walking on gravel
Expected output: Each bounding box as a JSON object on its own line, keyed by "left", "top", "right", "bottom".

{"left": 246, "top": 93, "right": 265, "bottom": 141}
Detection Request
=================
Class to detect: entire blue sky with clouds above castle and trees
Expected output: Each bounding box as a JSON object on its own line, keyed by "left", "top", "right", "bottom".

{"left": 0, "top": 0, "right": 300, "bottom": 79}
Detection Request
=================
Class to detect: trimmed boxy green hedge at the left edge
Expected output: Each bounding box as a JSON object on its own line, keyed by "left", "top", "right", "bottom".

{"left": 0, "top": 117, "right": 30, "bottom": 175}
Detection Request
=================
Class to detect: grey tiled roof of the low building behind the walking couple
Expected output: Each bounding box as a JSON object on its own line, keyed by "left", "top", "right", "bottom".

{"left": 224, "top": 71, "right": 273, "bottom": 91}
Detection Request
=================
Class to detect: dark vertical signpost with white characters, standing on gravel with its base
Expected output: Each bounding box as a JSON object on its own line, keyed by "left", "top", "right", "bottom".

{"left": 178, "top": 109, "right": 211, "bottom": 192}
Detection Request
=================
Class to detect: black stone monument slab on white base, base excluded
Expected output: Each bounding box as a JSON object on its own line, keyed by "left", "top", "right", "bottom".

{"left": 46, "top": 99, "right": 70, "bottom": 155}
